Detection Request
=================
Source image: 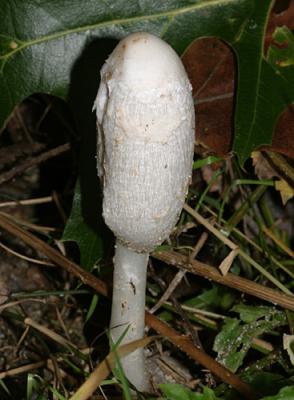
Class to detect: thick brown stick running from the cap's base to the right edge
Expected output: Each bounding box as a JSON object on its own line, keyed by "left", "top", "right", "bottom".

{"left": 152, "top": 252, "right": 294, "bottom": 311}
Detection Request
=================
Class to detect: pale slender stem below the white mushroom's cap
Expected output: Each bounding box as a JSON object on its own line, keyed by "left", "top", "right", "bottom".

{"left": 110, "top": 241, "right": 149, "bottom": 391}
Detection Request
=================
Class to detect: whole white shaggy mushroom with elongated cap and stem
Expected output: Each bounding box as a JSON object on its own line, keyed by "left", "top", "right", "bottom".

{"left": 94, "top": 32, "right": 195, "bottom": 390}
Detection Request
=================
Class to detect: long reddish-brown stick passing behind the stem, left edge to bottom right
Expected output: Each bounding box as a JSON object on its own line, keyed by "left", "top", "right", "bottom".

{"left": 0, "top": 214, "right": 254, "bottom": 400}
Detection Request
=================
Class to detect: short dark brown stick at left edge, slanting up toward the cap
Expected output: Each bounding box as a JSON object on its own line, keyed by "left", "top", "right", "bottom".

{"left": 0, "top": 143, "right": 70, "bottom": 185}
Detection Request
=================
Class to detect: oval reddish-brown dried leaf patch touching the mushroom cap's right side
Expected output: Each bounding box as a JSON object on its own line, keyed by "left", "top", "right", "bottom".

{"left": 183, "top": 38, "right": 235, "bottom": 155}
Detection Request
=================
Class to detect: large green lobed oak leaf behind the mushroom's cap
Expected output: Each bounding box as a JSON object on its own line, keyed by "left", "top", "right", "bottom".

{"left": 0, "top": 0, "right": 294, "bottom": 264}
